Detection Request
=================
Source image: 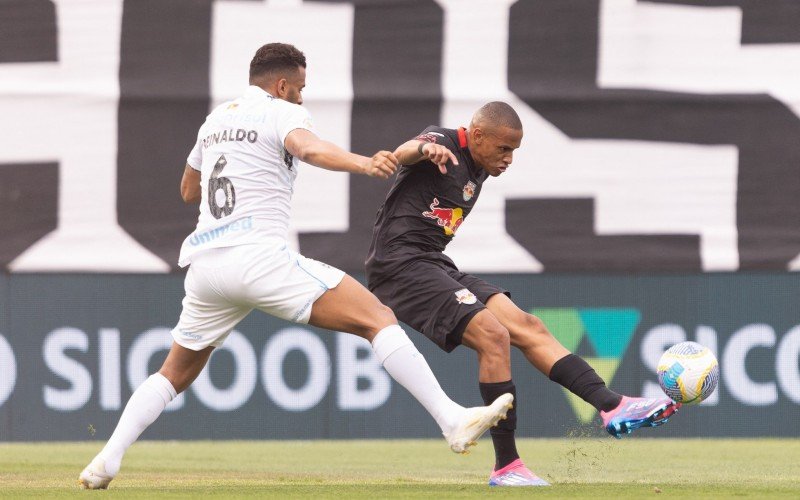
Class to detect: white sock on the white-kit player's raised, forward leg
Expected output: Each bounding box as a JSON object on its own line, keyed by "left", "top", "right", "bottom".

{"left": 372, "top": 325, "right": 463, "bottom": 433}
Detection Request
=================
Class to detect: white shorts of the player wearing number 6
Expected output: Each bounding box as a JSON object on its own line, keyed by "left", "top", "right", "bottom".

{"left": 172, "top": 239, "right": 344, "bottom": 351}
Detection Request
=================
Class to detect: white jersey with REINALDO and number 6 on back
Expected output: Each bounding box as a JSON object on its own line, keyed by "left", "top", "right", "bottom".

{"left": 178, "top": 85, "right": 311, "bottom": 267}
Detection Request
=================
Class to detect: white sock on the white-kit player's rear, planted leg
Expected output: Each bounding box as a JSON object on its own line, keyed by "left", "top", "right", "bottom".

{"left": 98, "top": 372, "right": 177, "bottom": 476}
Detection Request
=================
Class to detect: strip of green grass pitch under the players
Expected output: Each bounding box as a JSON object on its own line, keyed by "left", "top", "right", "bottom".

{"left": 0, "top": 438, "right": 800, "bottom": 499}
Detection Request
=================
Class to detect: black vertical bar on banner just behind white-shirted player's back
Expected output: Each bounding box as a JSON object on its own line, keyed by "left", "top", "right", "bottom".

{"left": 117, "top": 0, "right": 212, "bottom": 269}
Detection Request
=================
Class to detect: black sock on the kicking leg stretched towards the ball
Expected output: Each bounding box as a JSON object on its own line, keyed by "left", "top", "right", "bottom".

{"left": 550, "top": 354, "right": 622, "bottom": 411}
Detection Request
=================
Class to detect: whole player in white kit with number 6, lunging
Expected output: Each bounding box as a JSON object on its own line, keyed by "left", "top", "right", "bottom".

{"left": 79, "top": 43, "right": 513, "bottom": 489}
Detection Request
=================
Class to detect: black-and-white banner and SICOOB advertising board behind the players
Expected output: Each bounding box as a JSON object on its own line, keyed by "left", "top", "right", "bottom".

{"left": 0, "top": 0, "right": 800, "bottom": 441}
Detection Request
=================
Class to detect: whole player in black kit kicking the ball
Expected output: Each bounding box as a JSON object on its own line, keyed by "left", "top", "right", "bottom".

{"left": 366, "top": 102, "right": 680, "bottom": 486}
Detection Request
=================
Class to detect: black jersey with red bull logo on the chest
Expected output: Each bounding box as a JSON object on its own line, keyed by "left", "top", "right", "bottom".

{"left": 366, "top": 126, "right": 489, "bottom": 286}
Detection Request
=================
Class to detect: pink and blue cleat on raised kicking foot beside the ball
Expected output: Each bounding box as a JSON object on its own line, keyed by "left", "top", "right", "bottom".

{"left": 600, "top": 396, "right": 681, "bottom": 439}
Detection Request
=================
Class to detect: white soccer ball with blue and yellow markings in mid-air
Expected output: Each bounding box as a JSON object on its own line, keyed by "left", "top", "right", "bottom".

{"left": 657, "top": 342, "right": 719, "bottom": 405}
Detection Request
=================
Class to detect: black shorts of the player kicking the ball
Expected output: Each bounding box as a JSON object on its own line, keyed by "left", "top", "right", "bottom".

{"left": 370, "top": 260, "right": 511, "bottom": 352}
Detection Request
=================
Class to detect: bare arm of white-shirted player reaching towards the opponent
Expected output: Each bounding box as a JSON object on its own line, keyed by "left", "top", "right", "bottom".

{"left": 284, "top": 128, "right": 397, "bottom": 179}
